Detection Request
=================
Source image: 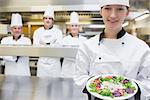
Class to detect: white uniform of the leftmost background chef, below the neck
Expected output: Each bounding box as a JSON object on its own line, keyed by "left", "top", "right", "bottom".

{"left": 1, "top": 35, "right": 31, "bottom": 76}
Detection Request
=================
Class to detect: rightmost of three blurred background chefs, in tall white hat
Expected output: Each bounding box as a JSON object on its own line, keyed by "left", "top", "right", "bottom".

{"left": 61, "top": 12, "right": 87, "bottom": 78}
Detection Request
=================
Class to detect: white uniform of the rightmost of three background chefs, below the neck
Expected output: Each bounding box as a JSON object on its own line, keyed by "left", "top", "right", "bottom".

{"left": 61, "top": 35, "right": 87, "bottom": 78}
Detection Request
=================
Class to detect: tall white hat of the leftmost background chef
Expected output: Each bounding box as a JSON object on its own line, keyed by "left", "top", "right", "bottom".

{"left": 10, "top": 13, "right": 22, "bottom": 27}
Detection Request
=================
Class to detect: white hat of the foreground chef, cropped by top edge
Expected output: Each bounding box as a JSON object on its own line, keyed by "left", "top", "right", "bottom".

{"left": 99, "top": 0, "right": 129, "bottom": 8}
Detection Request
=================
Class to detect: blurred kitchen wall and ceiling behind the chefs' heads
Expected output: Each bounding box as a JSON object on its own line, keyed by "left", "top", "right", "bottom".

{"left": 0, "top": 0, "right": 150, "bottom": 44}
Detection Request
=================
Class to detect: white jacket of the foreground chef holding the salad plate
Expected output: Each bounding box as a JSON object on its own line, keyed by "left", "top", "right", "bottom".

{"left": 74, "top": 33, "right": 150, "bottom": 100}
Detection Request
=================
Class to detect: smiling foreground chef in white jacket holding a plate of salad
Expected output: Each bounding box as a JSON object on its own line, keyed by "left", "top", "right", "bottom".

{"left": 74, "top": 0, "right": 150, "bottom": 100}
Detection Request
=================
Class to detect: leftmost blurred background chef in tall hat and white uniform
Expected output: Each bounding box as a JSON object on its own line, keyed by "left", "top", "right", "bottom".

{"left": 1, "top": 13, "right": 31, "bottom": 76}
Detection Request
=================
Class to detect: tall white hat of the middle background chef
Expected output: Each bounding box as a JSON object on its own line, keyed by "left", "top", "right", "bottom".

{"left": 43, "top": 5, "right": 54, "bottom": 19}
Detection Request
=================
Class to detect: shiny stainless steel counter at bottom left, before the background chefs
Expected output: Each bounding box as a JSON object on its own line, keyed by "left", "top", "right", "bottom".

{"left": 0, "top": 75, "right": 86, "bottom": 100}
